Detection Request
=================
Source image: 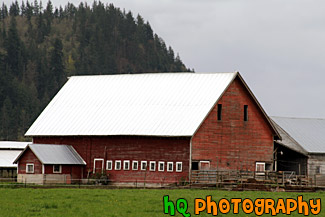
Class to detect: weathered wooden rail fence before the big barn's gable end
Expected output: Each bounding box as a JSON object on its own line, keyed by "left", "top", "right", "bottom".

{"left": 191, "top": 170, "right": 325, "bottom": 191}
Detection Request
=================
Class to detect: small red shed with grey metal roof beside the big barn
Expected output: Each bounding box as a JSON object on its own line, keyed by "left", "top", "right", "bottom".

{"left": 14, "top": 144, "right": 86, "bottom": 184}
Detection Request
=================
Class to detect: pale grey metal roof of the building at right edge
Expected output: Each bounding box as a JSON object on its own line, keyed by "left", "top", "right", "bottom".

{"left": 271, "top": 117, "right": 325, "bottom": 153}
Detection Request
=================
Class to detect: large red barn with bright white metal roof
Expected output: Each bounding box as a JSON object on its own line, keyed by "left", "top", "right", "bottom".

{"left": 19, "top": 72, "right": 279, "bottom": 184}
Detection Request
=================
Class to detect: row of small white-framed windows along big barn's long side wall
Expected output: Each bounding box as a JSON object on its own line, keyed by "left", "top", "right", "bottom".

{"left": 106, "top": 160, "right": 183, "bottom": 172}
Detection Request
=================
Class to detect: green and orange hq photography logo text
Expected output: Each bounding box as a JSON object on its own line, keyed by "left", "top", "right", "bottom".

{"left": 163, "top": 195, "right": 321, "bottom": 217}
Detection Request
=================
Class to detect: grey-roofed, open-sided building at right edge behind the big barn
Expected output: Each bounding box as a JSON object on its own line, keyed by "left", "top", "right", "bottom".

{"left": 271, "top": 117, "right": 325, "bottom": 185}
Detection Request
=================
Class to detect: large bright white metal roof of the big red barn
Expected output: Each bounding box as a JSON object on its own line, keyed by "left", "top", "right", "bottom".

{"left": 25, "top": 72, "right": 237, "bottom": 136}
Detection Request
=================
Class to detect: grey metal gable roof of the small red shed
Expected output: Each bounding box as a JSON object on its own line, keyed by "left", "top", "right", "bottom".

{"left": 14, "top": 144, "right": 86, "bottom": 165}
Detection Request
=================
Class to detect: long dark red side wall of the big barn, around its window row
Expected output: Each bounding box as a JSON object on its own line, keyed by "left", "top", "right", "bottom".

{"left": 33, "top": 136, "right": 190, "bottom": 183}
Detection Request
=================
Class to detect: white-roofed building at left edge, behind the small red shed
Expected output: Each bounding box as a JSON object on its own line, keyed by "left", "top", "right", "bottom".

{"left": 0, "top": 141, "right": 28, "bottom": 178}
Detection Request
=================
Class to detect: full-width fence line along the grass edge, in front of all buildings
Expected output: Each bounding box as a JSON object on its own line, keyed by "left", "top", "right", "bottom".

{"left": 0, "top": 170, "right": 325, "bottom": 191}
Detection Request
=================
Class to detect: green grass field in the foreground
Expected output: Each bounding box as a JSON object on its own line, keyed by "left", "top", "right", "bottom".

{"left": 0, "top": 188, "right": 325, "bottom": 217}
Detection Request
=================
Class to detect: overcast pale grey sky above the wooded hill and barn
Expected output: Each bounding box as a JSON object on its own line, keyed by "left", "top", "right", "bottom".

{"left": 4, "top": 0, "right": 325, "bottom": 118}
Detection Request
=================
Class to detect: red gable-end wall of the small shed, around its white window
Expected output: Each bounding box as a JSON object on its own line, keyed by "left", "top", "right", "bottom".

{"left": 18, "top": 148, "right": 42, "bottom": 174}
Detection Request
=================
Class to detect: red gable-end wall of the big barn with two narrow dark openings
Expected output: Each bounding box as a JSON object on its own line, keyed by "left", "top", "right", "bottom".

{"left": 192, "top": 77, "right": 274, "bottom": 171}
